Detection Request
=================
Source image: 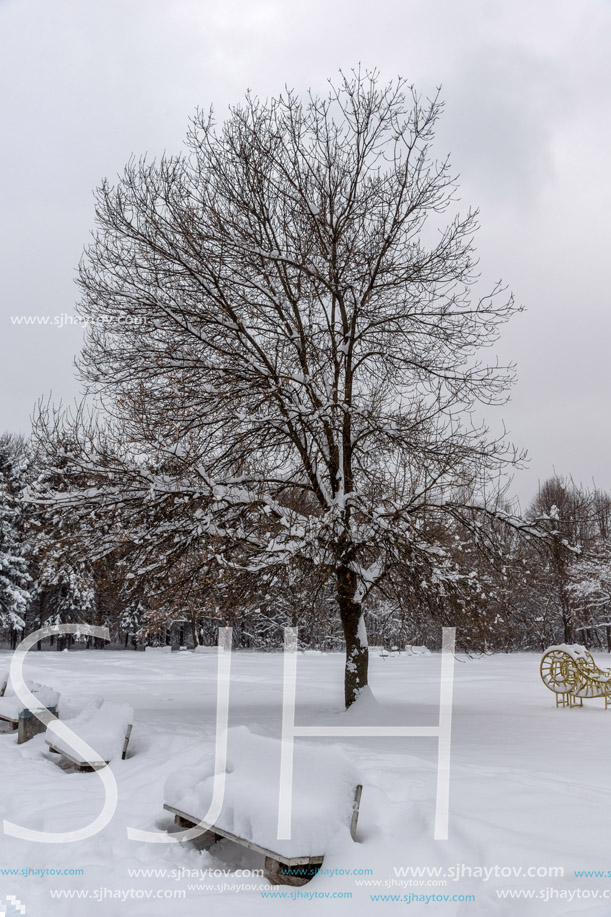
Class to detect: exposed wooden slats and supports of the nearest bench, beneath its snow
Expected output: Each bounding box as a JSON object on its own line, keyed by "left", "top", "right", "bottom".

{"left": 163, "top": 784, "right": 363, "bottom": 886}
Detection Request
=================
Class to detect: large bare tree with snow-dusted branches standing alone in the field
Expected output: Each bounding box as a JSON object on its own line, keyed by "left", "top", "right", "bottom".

{"left": 32, "top": 73, "right": 516, "bottom": 705}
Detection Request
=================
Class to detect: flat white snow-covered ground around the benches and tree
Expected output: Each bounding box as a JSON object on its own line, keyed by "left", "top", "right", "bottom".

{"left": 0, "top": 651, "right": 611, "bottom": 917}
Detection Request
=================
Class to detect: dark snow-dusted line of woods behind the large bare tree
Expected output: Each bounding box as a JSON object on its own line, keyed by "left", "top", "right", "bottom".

{"left": 0, "top": 434, "right": 611, "bottom": 652}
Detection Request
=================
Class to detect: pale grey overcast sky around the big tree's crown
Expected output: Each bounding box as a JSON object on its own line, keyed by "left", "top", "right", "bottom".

{"left": 0, "top": 0, "right": 611, "bottom": 502}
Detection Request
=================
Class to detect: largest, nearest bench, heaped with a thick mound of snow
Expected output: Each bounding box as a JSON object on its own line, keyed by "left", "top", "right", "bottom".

{"left": 164, "top": 726, "right": 362, "bottom": 885}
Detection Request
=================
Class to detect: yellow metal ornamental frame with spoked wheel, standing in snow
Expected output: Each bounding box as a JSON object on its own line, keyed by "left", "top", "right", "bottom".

{"left": 540, "top": 644, "right": 611, "bottom": 709}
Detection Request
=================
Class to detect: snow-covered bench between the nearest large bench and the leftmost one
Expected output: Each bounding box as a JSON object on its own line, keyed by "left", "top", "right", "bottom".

{"left": 46, "top": 697, "right": 134, "bottom": 771}
